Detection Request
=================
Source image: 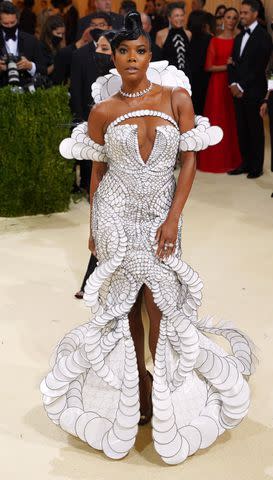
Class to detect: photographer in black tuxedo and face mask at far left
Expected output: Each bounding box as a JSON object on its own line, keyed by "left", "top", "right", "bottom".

{"left": 0, "top": 1, "right": 46, "bottom": 87}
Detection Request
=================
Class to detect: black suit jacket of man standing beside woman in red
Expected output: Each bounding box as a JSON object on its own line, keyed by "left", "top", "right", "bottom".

{"left": 228, "top": 25, "right": 272, "bottom": 100}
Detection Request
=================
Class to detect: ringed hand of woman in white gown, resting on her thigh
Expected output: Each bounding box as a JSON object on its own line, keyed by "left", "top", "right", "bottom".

{"left": 155, "top": 219, "right": 178, "bottom": 258}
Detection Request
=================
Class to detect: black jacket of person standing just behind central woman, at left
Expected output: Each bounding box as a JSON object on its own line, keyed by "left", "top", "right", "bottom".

{"left": 70, "top": 42, "right": 100, "bottom": 121}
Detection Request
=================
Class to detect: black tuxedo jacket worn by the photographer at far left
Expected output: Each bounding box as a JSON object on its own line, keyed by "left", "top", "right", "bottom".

{"left": 0, "top": 29, "right": 46, "bottom": 87}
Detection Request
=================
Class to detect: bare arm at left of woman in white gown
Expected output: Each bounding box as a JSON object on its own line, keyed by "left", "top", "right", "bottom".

{"left": 88, "top": 105, "right": 107, "bottom": 256}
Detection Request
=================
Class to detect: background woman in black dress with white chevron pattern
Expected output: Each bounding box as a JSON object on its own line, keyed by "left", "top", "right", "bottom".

{"left": 155, "top": 2, "right": 191, "bottom": 77}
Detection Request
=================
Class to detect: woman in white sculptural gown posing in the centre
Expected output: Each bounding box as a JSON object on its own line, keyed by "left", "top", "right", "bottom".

{"left": 41, "top": 12, "right": 252, "bottom": 464}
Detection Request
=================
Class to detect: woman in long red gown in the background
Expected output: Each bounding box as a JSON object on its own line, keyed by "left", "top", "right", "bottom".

{"left": 197, "top": 8, "right": 242, "bottom": 173}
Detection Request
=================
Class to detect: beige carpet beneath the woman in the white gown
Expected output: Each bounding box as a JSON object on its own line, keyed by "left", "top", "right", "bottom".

{"left": 0, "top": 132, "right": 273, "bottom": 480}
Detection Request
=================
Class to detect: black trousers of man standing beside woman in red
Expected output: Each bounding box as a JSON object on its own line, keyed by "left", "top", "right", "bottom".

{"left": 234, "top": 97, "right": 264, "bottom": 174}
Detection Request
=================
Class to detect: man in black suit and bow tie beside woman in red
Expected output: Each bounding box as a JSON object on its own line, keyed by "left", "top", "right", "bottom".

{"left": 228, "top": 0, "right": 272, "bottom": 178}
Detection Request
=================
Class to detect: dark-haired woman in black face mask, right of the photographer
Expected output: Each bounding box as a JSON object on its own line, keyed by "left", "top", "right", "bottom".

{"left": 40, "top": 15, "right": 65, "bottom": 77}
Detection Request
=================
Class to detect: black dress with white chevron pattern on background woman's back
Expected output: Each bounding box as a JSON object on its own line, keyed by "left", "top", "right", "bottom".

{"left": 162, "top": 28, "right": 190, "bottom": 77}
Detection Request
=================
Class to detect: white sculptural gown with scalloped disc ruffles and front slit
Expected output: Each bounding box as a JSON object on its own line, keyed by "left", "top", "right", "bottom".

{"left": 41, "top": 110, "right": 253, "bottom": 464}
